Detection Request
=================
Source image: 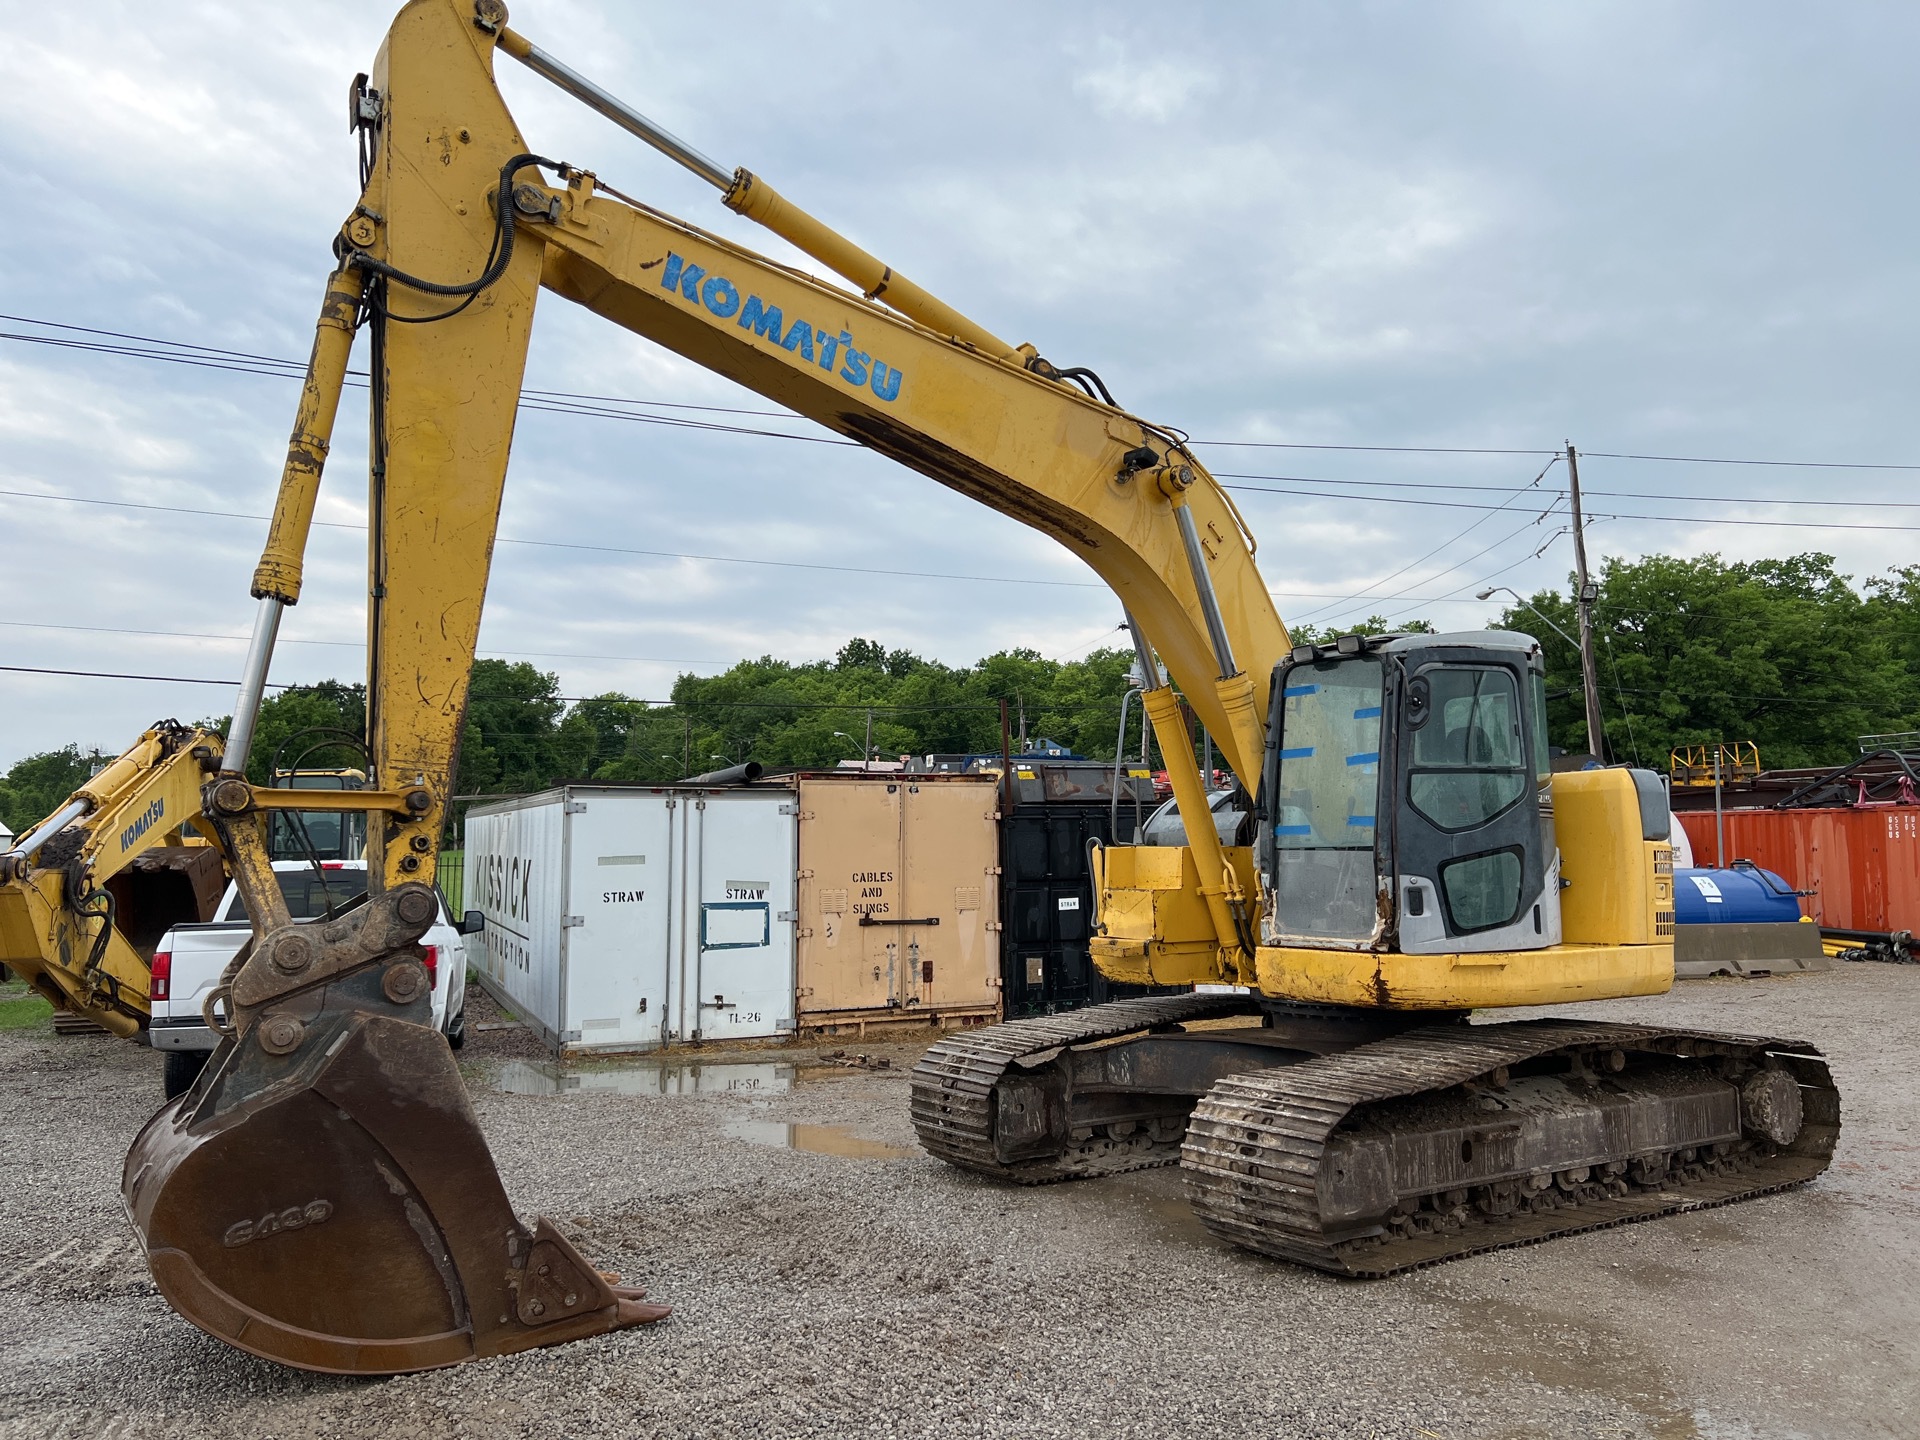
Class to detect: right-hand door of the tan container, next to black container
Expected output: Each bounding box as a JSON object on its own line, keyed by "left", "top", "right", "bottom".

{"left": 891, "top": 781, "right": 1000, "bottom": 1010}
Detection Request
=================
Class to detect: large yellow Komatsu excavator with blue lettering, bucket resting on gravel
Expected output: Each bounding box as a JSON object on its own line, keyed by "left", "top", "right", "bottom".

{"left": 15, "top": 0, "right": 1837, "bottom": 1373}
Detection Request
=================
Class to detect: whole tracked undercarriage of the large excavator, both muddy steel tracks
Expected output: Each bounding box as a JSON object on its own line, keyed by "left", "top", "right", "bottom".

{"left": 912, "top": 995, "right": 1839, "bottom": 1277}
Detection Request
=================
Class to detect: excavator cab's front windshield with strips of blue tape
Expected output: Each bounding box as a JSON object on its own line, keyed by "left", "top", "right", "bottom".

{"left": 1273, "top": 655, "right": 1382, "bottom": 941}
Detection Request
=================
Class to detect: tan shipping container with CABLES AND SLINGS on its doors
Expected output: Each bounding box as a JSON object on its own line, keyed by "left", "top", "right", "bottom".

{"left": 797, "top": 774, "right": 1000, "bottom": 1035}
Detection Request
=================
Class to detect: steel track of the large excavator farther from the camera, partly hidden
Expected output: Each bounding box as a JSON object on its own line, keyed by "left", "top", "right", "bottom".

{"left": 912, "top": 995, "right": 1254, "bottom": 1185}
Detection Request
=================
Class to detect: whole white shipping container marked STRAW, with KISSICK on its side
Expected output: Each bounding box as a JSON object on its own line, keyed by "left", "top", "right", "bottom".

{"left": 465, "top": 785, "right": 797, "bottom": 1050}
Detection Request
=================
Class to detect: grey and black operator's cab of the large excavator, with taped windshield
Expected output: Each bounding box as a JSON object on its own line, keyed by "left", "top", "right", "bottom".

{"left": 1260, "top": 630, "right": 1561, "bottom": 954}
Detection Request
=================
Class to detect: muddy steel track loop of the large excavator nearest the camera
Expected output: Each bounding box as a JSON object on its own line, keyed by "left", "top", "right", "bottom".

{"left": 1181, "top": 1020, "right": 1839, "bottom": 1277}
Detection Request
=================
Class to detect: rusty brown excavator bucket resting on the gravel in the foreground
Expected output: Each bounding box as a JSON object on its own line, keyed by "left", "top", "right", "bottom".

{"left": 121, "top": 897, "right": 668, "bottom": 1375}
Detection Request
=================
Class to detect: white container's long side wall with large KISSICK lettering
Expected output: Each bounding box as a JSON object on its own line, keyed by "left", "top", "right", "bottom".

{"left": 461, "top": 795, "right": 566, "bottom": 1039}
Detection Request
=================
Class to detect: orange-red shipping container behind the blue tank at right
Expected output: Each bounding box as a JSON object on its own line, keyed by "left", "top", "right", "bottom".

{"left": 1676, "top": 806, "right": 1920, "bottom": 933}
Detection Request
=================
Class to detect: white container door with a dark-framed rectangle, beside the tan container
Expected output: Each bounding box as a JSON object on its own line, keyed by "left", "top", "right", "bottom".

{"left": 682, "top": 791, "right": 797, "bottom": 1041}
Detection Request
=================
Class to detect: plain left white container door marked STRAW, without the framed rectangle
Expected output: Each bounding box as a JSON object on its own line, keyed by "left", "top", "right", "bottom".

{"left": 566, "top": 791, "right": 674, "bottom": 1050}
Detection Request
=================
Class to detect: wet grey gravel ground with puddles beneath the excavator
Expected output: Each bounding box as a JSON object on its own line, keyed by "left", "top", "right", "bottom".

{"left": 0, "top": 966, "right": 1920, "bottom": 1440}
